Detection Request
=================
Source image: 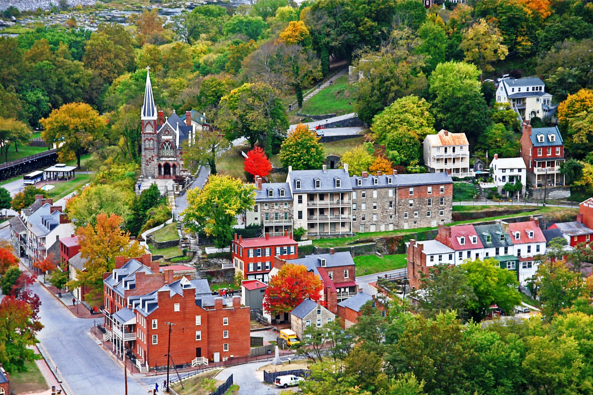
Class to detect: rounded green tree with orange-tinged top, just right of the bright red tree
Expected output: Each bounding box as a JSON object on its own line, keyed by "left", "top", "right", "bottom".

{"left": 280, "top": 124, "right": 325, "bottom": 170}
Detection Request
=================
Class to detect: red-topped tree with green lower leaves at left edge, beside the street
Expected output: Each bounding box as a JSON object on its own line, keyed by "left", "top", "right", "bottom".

{"left": 0, "top": 296, "right": 43, "bottom": 373}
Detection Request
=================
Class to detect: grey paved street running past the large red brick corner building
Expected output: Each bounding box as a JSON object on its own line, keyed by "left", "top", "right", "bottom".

{"left": 33, "top": 283, "right": 148, "bottom": 395}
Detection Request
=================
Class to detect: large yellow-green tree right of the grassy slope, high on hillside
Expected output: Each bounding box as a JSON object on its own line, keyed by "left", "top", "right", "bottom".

{"left": 354, "top": 30, "right": 426, "bottom": 123}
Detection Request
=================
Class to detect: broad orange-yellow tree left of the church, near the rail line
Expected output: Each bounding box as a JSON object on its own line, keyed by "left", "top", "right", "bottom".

{"left": 40, "top": 103, "right": 106, "bottom": 167}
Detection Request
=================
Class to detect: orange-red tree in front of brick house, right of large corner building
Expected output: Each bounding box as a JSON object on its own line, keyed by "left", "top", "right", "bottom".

{"left": 263, "top": 263, "right": 323, "bottom": 316}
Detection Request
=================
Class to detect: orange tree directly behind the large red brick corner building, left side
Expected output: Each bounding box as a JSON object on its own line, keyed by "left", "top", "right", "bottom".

{"left": 68, "top": 213, "right": 145, "bottom": 293}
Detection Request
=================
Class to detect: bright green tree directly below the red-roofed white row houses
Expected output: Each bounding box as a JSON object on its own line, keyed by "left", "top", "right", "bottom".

{"left": 461, "top": 258, "right": 521, "bottom": 321}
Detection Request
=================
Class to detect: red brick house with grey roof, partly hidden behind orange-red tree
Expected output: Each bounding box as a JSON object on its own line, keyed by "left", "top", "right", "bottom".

{"left": 270, "top": 252, "right": 358, "bottom": 321}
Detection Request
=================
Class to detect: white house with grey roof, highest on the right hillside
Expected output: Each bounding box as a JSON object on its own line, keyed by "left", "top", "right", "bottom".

{"left": 496, "top": 76, "right": 556, "bottom": 120}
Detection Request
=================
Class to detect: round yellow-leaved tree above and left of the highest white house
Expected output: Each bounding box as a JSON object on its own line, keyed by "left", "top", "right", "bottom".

{"left": 459, "top": 19, "right": 509, "bottom": 79}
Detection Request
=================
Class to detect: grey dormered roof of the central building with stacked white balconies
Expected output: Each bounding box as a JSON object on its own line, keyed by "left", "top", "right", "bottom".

{"left": 287, "top": 169, "right": 352, "bottom": 193}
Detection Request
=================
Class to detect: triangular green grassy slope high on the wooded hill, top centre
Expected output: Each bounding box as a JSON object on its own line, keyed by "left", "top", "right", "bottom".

{"left": 294, "top": 75, "right": 356, "bottom": 115}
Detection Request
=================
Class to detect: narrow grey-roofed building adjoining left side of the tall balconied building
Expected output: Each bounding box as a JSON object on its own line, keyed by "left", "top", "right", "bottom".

{"left": 245, "top": 177, "right": 293, "bottom": 236}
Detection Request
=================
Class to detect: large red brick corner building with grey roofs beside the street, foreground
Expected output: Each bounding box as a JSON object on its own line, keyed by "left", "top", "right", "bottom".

{"left": 104, "top": 255, "right": 250, "bottom": 369}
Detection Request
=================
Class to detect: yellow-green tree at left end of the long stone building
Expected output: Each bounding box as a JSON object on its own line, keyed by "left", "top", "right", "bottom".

{"left": 182, "top": 175, "right": 255, "bottom": 248}
